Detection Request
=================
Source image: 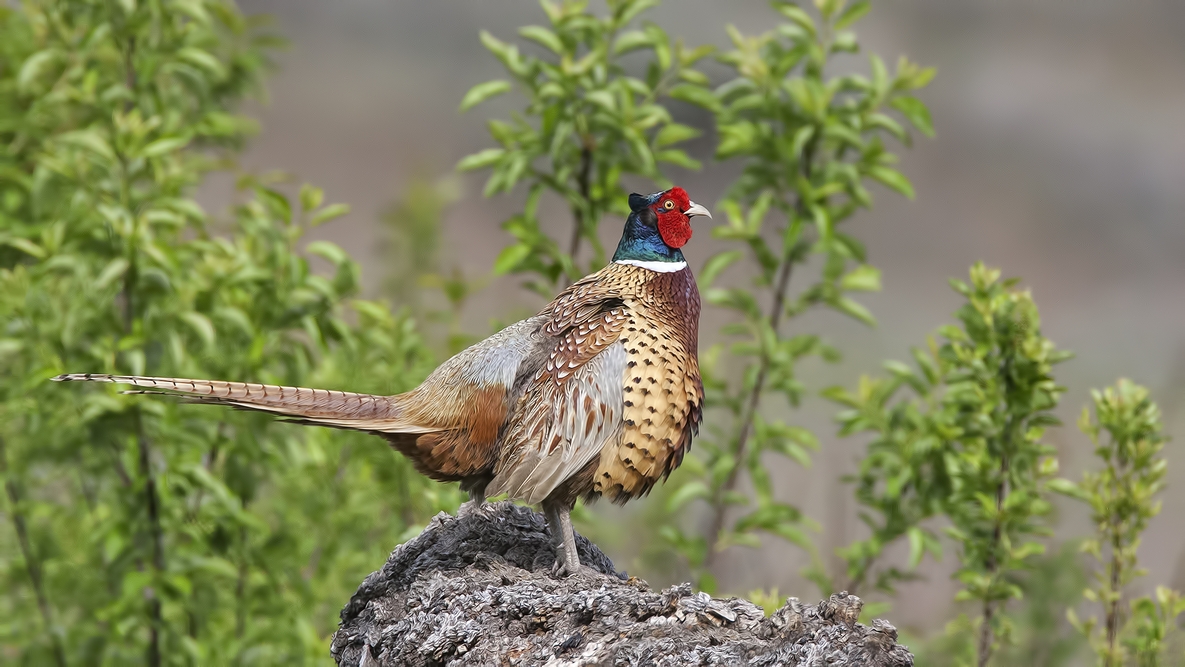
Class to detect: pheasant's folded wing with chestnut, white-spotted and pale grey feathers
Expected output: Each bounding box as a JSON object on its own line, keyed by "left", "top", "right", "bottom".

{"left": 486, "top": 274, "right": 629, "bottom": 504}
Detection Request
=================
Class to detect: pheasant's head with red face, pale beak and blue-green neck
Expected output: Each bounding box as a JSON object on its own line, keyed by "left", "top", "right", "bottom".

{"left": 613, "top": 187, "right": 712, "bottom": 268}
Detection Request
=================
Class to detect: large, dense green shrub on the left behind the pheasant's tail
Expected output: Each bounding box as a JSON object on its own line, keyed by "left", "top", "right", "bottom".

{"left": 0, "top": 0, "right": 447, "bottom": 665}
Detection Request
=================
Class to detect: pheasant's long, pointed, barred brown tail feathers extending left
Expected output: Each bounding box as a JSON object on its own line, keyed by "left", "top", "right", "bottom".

{"left": 53, "top": 373, "right": 422, "bottom": 432}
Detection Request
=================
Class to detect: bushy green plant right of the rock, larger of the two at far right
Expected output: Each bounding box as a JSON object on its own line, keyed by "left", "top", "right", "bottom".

{"left": 827, "top": 264, "right": 1070, "bottom": 667}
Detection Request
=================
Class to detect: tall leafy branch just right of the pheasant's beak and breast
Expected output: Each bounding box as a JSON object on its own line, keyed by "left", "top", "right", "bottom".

{"left": 664, "top": 0, "right": 934, "bottom": 589}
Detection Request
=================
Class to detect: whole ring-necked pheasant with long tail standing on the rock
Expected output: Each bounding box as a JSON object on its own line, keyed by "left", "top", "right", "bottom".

{"left": 53, "top": 187, "right": 711, "bottom": 576}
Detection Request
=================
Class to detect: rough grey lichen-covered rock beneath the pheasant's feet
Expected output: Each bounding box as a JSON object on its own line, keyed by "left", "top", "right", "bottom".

{"left": 332, "top": 502, "right": 914, "bottom": 667}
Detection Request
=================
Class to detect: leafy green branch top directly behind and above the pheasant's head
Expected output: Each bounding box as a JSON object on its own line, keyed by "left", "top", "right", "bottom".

{"left": 457, "top": 0, "right": 712, "bottom": 297}
